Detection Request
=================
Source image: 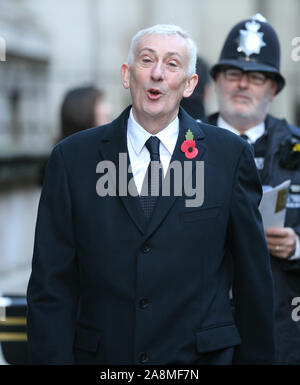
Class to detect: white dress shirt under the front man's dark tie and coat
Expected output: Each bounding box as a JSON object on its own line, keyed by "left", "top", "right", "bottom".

{"left": 127, "top": 109, "right": 179, "bottom": 194}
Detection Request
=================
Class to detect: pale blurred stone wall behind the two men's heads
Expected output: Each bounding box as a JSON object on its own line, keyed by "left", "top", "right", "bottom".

{"left": 11, "top": 0, "right": 300, "bottom": 137}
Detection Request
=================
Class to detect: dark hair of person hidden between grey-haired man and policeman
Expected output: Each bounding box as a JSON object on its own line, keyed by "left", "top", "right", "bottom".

{"left": 181, "top": 56, "right": 209, "bottom": 119}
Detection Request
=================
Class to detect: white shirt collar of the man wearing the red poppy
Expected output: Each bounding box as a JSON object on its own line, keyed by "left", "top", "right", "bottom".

{"left": 127, "top": 109, "right": 179, "bottom": 155}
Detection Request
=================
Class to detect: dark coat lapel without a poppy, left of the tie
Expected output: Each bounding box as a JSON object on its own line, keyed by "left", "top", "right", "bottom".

{"left": 99, "top": 107, "right": 147, "bottom": 233}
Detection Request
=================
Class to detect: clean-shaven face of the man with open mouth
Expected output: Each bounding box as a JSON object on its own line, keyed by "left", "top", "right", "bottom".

{"left": 122, "top": 34, "right": 198, "bottom": 124}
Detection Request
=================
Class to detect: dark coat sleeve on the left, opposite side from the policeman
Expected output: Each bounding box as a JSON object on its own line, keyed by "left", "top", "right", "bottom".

{"left": 27, "top": 145, "right": 78, "bottom": 364}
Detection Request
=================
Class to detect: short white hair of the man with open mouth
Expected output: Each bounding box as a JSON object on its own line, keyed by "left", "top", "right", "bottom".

{"left": 127, "top": 24, "right": 197, "bottom": 76}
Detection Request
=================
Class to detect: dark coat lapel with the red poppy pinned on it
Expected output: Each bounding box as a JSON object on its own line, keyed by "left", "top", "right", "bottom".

{"left": 145, "top": 108, "right": 206, "bottom": 238}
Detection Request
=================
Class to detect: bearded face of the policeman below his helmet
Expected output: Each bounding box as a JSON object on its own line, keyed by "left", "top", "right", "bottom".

{"left": 216, "top": 68, "right": 277, "bottom": 128}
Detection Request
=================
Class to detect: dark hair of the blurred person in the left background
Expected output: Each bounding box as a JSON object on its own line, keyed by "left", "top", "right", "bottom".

{"left": 61, "top": 86, "right": 103, "bottom": 139}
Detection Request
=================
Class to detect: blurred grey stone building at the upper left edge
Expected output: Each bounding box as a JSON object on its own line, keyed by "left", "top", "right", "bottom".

{"left": 0, "top": 0, "right": 49, "bottom": 156}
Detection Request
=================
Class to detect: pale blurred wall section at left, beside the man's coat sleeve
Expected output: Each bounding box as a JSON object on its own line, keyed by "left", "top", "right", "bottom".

{"left": 0, "top": 186, "right": 40, "bottom": 294}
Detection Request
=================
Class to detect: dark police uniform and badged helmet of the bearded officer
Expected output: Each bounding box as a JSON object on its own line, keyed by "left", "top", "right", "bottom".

{"left": 205, "top": 15, "right": 300, "bottom": 364}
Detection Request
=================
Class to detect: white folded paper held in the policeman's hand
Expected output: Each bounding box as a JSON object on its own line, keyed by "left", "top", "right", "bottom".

{"left": 259, "top": 180, "right": 291, "bottom": 229}
